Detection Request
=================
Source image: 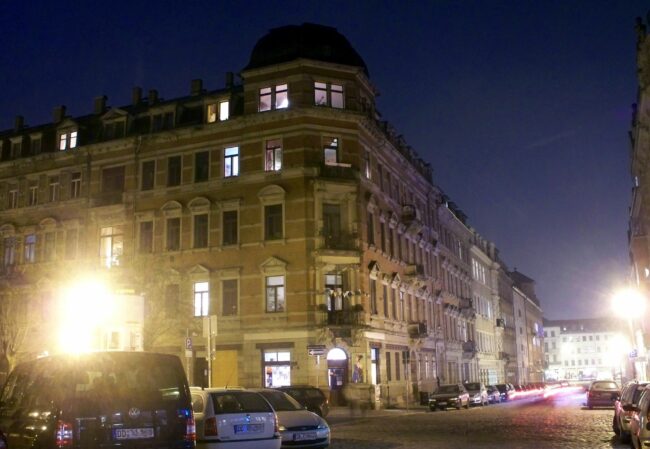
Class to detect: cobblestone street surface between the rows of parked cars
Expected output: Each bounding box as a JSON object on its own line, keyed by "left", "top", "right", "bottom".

{"left": 328, "top": 393, "right": 629, "bottom": 449}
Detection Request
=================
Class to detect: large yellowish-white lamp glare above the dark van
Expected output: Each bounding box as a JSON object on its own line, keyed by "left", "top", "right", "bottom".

{"left": 58, "top": 279, "right": 113, "bottom": 353}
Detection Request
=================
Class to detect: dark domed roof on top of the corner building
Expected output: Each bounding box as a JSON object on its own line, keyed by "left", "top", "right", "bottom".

{"left": 244, "top": 23, "right": 370, "bottom": 77}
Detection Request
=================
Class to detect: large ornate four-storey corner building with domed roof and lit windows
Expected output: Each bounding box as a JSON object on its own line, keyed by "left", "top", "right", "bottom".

{"left": 0, "top": 24, "right": 446, "bottom": 406}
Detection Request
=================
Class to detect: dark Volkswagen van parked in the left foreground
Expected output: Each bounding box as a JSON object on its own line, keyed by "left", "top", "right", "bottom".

{"left": 0, "top": 352, "right": 196, "bottom": 449}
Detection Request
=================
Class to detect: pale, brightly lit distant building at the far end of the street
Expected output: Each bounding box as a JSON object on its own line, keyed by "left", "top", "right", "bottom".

{"left": 544, "top": 318, "right": 629, "bottom": 381}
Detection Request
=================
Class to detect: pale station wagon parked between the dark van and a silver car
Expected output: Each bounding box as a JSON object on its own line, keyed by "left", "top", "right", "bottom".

{"left": 190, "top": 387, "right": 282, "bottom": 449}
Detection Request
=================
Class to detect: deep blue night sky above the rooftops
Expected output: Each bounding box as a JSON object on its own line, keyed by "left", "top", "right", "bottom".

{"left": 0, "top": 0, "right": 650, "bottom": 319}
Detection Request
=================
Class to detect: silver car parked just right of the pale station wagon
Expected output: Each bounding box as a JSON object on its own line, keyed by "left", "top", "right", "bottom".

{"left": 253, "top": 388, "right": 330, "bottom": 449}
